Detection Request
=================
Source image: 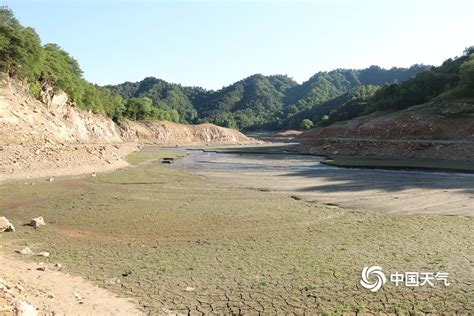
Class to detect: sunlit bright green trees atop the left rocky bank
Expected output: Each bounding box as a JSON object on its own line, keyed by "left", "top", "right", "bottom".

{"left": 0, "top": 7, "right": 179, "bottom": 121}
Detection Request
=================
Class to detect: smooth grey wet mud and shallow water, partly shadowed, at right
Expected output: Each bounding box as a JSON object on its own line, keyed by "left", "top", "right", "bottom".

{"left": 174, "top": 150, "right": 474, "bottom": 217}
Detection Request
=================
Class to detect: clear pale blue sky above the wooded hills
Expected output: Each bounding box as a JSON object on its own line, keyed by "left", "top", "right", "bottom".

{"left": 2, "top": 0, "right": 474, "bottom": 89}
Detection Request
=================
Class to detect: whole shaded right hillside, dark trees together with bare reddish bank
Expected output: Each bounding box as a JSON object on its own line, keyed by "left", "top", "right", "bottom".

{"left": 297, "top": 48, "right": 474, "bottom": 163}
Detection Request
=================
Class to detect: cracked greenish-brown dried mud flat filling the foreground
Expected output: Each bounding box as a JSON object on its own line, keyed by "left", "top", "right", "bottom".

{"left": 0, "top": 149, "right": 474, "bottom": 315}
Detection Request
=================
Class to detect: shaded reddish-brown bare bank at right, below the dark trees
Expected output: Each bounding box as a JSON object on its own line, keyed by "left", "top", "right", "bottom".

{"left": 297, "top": 103, "right": 474, "bottom": 160}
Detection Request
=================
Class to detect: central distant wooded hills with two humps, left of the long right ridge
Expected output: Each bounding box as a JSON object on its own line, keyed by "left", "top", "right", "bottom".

{"left": 107, "top": 75, "right": 297, "bottom": 128}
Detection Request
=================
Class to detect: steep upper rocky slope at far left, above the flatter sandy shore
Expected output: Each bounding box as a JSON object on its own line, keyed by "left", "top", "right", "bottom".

{"left": 0, "top": 74, "right": 122, "bottom": 146}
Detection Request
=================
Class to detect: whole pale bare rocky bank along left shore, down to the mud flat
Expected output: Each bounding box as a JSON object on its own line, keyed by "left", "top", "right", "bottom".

{"left": 0, "top": 74, "right": 255, "bottom": 181}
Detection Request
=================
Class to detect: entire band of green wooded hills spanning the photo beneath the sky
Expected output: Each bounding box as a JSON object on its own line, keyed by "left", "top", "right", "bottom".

{"left": 0, "top": 7, "right": 474, "bottom": 130}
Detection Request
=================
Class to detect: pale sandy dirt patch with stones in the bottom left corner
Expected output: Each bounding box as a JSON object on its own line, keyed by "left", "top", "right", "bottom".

{"left": 0, "top": 252, "right": 142, "bottom": 315}
